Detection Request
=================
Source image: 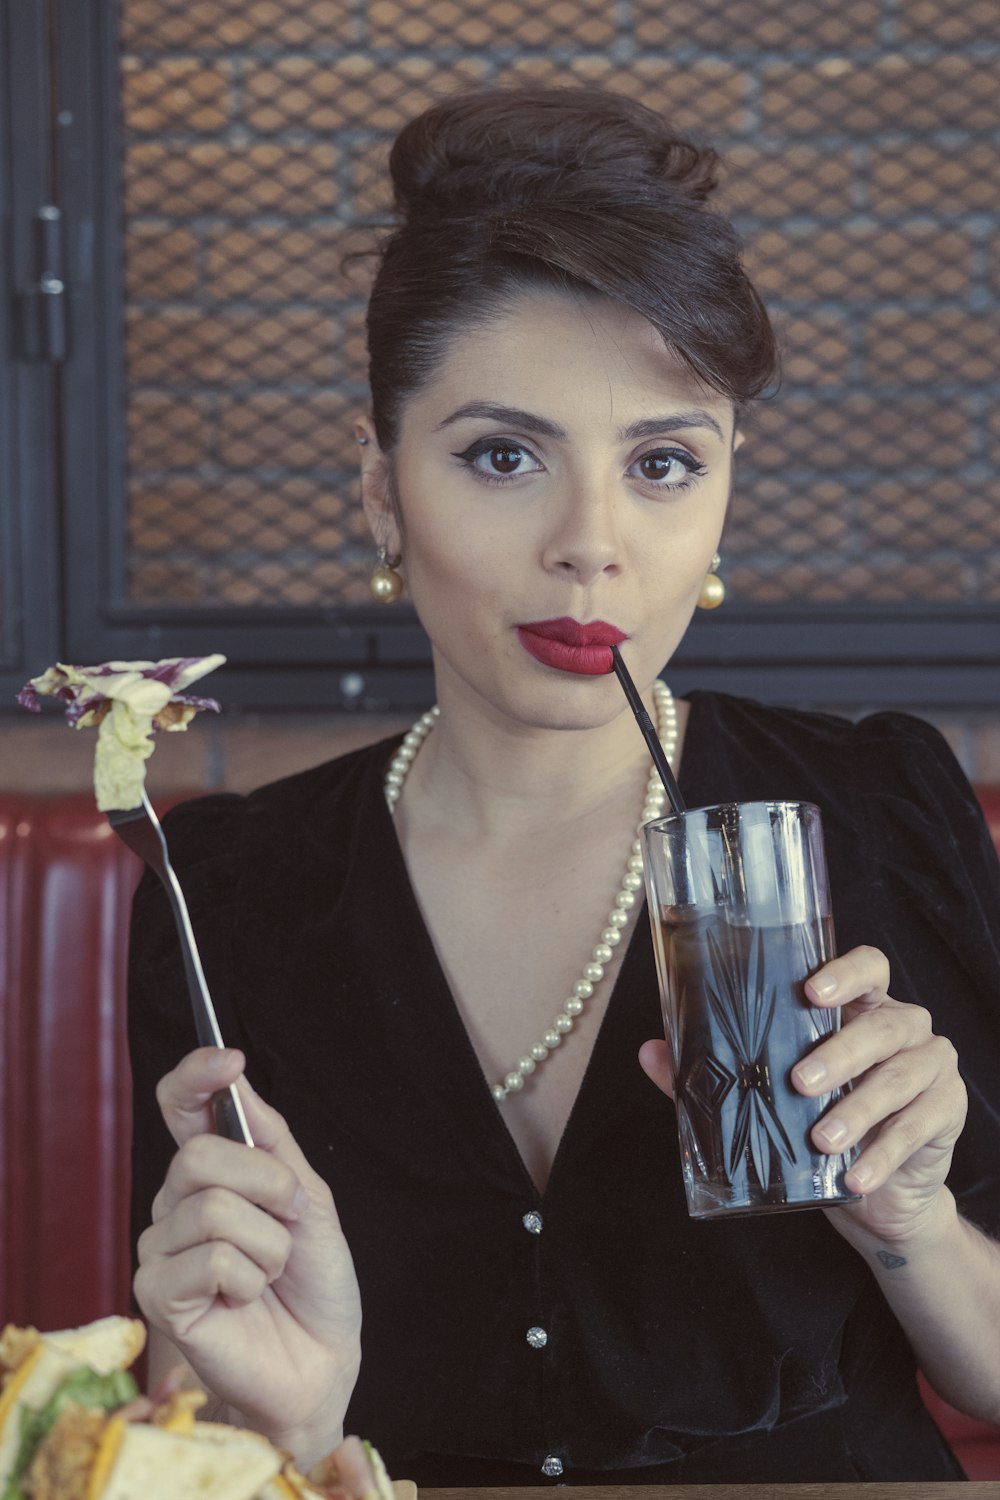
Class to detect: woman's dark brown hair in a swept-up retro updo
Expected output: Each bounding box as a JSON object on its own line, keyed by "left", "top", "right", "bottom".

{"left": 367, "top": 89, "right": 777, "bottom": 452}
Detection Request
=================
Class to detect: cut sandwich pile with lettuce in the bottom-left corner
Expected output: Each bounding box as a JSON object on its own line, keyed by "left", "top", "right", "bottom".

{"left": 0, "top": 1319, "right": 415, "bottom": 1500}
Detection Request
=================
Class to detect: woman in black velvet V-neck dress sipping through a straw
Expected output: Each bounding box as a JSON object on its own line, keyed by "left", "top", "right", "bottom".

{"left": 132, "top": 92, "right": 1000, "bottom": 1485}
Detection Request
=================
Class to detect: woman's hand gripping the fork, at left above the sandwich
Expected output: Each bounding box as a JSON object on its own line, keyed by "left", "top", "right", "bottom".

{"left": 135, "top": 1047, "right": 361, "bottom": 1463}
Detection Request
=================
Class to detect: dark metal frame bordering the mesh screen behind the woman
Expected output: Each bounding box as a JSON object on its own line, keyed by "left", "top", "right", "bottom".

{"left": 17, "top": 0, "right": 1000, "bottom": 713}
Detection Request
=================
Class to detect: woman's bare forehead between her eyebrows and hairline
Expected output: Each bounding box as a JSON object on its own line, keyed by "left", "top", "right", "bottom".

{"left": 405, "top": 291, "right": 733, "bottom": 432}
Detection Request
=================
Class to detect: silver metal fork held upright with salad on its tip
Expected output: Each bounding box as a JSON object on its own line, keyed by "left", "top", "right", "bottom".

{"left": 108, "top": 791, "right": 253, "bottom": 1146}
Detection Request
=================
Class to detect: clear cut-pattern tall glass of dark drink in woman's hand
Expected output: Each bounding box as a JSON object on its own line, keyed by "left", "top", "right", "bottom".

{"left": 643, "top": 803, "right": 858, "bottom": 1218}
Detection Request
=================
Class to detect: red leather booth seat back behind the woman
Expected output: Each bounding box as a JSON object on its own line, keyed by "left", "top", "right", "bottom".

{"left": 0, "top": 788, "right": 1000, "bottom": 1479}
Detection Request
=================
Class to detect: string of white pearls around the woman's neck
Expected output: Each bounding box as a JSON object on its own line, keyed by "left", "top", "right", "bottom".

{"left": 385, "top": 681, "right": 678, "bottom": 1104}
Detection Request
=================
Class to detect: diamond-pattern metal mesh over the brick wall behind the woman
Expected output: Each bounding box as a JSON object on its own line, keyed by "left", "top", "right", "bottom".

{"left": 121, "top": 0, "right": 1000, "bottom": 608}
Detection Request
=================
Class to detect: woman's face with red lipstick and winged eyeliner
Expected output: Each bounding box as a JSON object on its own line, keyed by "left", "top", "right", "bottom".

{"left": 364, "top": 293, "right": 733, "bottom": 728}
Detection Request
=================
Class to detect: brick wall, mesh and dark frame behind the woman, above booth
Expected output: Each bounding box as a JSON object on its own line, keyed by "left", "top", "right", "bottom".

{"left": 0, "top": 0, "right": 1000, "bottom": 792}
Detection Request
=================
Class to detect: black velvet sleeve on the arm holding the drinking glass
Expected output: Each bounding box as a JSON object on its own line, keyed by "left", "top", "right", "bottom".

{"left": 858, "top": 714, "right": 1000, "bottom": 1238}
